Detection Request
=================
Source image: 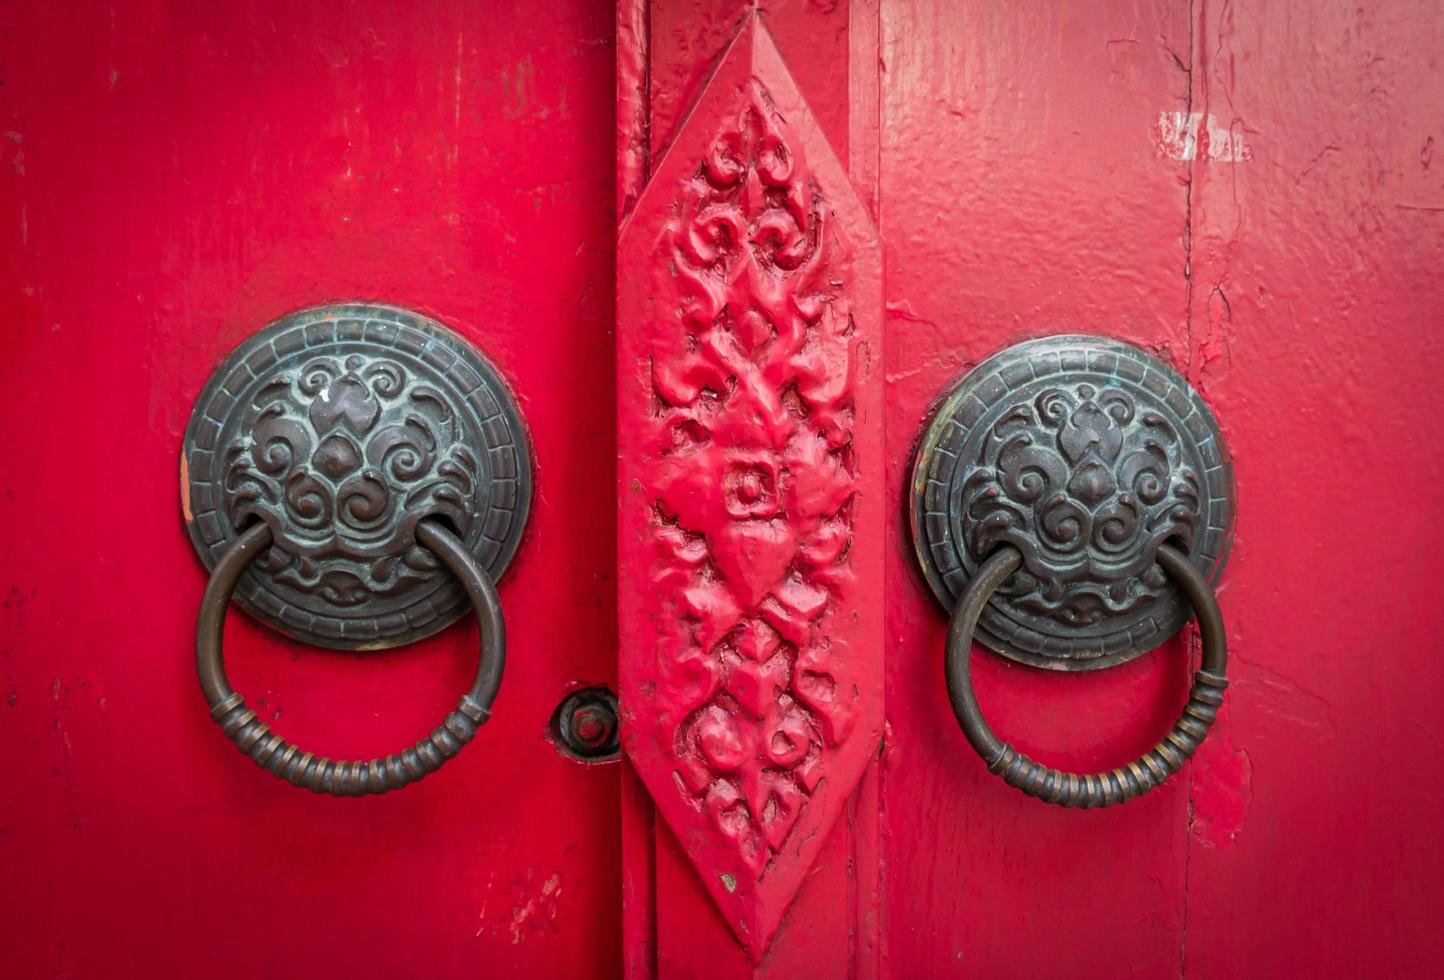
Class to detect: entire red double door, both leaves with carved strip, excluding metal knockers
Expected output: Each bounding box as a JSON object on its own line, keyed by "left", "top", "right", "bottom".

{"left": 0, "top": 0, "right": 1444, "bottom": 977}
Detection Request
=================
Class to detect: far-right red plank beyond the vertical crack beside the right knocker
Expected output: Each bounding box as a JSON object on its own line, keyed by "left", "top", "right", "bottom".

{"left": 1183, "top": 3, "right": 1444, "bottom": 977}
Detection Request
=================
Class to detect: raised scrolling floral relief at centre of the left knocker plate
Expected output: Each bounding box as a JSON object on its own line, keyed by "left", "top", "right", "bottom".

{"left": 225, "top": 354, "right": 481, "bottom": 608}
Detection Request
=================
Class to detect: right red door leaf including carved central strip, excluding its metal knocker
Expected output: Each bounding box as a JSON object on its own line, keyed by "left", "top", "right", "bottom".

{"left": 617, "top": 0, "right": 1444, "bottom": 977}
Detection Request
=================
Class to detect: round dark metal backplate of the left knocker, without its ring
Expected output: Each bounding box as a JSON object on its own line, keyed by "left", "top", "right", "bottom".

{"left": 181, "top": 305, "right": 531, "bottom": 649}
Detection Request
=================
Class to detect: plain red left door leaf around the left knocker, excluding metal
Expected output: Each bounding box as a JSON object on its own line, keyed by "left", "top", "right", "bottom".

{"left": 0, "top": 1, "right": 621, "bottom": 979}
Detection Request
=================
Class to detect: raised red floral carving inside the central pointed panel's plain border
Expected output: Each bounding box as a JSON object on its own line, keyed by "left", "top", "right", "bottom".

{"left": 650, "top": 82, "right": 858, "bottom": 876}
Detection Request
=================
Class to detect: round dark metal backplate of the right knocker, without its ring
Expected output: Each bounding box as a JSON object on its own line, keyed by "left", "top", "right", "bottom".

{"left": 911, "top": 335, "right": 1233, "bottom": 670}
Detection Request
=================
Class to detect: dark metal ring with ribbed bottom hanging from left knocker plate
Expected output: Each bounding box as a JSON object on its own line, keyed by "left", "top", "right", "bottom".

{"left": 195, "top": 521, "right": 507, "bottom": 797}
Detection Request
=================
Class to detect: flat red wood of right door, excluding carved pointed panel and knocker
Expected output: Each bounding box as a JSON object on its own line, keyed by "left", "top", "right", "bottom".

{"left": 618, "top": 0, "right": 1444, "bottom": 977}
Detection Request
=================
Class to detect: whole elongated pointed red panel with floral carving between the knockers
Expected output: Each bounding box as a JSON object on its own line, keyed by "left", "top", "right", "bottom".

{"left": 618, "top": 17, "right": 884, "bottom": 957}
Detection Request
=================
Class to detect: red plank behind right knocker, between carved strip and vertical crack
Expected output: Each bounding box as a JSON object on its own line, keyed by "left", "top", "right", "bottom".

{"left": 881, "top": 1, "right": 1190, "bottom": 977}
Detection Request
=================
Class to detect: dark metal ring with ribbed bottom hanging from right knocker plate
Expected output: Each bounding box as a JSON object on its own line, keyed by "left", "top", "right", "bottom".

{"left": 946, "top": 544, "right": 1229, "bottom": 807}
